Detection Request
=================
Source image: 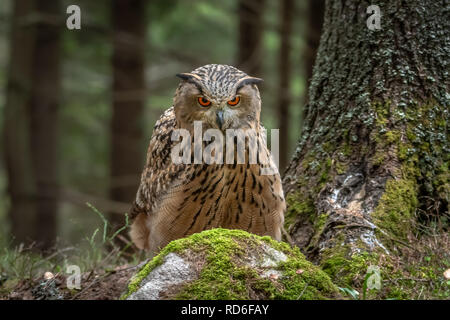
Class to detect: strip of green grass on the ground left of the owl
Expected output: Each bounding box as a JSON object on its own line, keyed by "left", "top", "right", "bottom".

{"left": 0, "top": 203, "right": 142, "bottom": 298}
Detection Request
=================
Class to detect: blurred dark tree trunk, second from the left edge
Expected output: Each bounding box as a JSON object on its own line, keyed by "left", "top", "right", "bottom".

{"left": 29, "top": 0, "right": 62, "bottom": 249}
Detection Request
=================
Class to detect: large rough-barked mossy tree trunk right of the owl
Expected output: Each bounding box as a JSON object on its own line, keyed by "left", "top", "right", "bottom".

{"left": 283, "top": 0, "right": 450, "bottom": 265}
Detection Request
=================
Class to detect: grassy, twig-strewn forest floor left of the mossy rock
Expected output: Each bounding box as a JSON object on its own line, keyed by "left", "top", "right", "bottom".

{"left": 0, "top": 203, "right": 146, "bottom": 300}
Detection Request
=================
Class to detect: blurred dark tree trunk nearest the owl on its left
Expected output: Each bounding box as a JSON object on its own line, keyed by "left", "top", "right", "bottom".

{"left": 110, "top": 0, "right": 147, "bottom": 228}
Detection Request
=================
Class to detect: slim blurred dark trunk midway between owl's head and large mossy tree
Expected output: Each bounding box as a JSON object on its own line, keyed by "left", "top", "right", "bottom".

{"left": 278, "top": 0, "right": 294, "bottom": 172}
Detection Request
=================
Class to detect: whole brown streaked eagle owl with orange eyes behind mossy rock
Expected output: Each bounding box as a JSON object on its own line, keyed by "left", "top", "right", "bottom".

{"left": 130, "top": 64, "right": 286, "bottom": 255}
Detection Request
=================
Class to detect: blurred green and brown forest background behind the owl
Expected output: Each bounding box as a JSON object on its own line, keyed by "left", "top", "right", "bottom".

{"left": 0, "top": 0, "right": 324, "bottom": 249}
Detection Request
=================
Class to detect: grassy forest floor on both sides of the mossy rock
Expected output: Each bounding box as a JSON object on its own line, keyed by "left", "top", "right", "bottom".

{"left": 0, "top": 206, "right": 450, "bottom": 300}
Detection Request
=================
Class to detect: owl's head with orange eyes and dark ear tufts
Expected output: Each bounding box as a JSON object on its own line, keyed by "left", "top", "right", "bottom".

{"left": 174, "top": 64, "right": 262, "bottom": 131}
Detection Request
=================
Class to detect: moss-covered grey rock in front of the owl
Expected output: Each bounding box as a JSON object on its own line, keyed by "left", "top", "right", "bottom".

{"left": 121, "top": 229, "right": 339, "bottom": 300}
